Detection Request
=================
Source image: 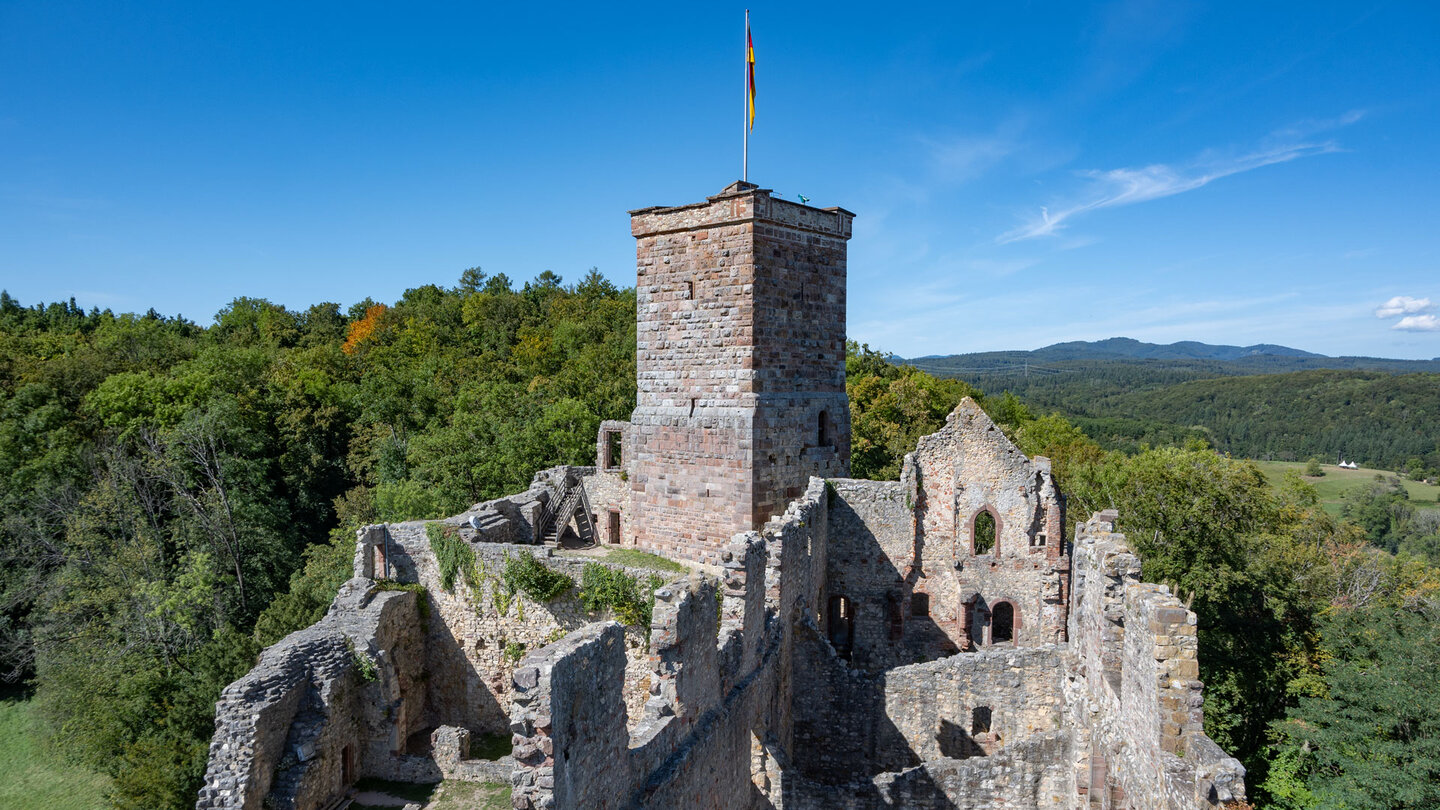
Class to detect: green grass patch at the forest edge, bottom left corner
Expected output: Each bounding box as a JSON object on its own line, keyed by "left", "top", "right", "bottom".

{"left": 0, "top": 699, "right": 109, "bottom": 810}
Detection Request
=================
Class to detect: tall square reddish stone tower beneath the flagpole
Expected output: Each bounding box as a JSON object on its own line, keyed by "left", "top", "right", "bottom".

{"left": 626, "top": 182, "right": 855, "bottom": 562}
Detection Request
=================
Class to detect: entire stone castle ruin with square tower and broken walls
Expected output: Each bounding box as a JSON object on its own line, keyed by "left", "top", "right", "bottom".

{"left": 196, "top": 183, "right": 1244, "bottom": 810}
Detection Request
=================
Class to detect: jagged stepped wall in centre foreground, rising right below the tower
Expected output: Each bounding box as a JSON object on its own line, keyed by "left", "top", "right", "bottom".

{"left": 511, "top": 479, "right": 827, "bottom": 810}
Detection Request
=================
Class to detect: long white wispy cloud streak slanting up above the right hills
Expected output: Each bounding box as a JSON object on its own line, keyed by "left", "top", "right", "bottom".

{"left": 995, "top": 110, "right": 1364, "bottom": 245}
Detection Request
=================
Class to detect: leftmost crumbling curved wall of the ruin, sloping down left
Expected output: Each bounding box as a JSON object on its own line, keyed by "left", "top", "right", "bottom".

{"left": 196, "top": 578, "right": 425, "bottom": 810}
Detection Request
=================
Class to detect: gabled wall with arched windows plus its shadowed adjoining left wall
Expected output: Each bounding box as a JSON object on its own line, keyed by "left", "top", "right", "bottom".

{"left": 821, "top": 399, "right": 1070, "bottom": 672}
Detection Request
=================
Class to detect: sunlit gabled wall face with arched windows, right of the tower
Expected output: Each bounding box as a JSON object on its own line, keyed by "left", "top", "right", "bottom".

{"left": 901, "top": 398, "right": 1070, "bottom": 650}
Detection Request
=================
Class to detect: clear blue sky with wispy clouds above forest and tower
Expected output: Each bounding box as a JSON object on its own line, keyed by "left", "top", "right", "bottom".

{"left": 0, "top": 0, "right": 1440, "bottom": 357}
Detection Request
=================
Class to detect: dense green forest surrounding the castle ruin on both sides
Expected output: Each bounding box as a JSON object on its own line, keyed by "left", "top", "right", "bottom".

{"left": 0, "top": 282, "right": 1440, "bottom": 810}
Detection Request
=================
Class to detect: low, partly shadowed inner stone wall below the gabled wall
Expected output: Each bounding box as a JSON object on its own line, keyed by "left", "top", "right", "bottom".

{"left": 786, "top": 611, "right": 1073, "bottom": 809}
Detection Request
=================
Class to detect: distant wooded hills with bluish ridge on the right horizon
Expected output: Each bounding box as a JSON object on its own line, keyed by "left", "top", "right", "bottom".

{"left": 906, "top": 337, "right": 1440, "bottom": 468}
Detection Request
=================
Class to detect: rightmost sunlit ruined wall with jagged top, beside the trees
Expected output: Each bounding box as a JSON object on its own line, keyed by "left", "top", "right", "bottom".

{"left": 1066, "top": 512, "right": 1244, "bottom": 810}
